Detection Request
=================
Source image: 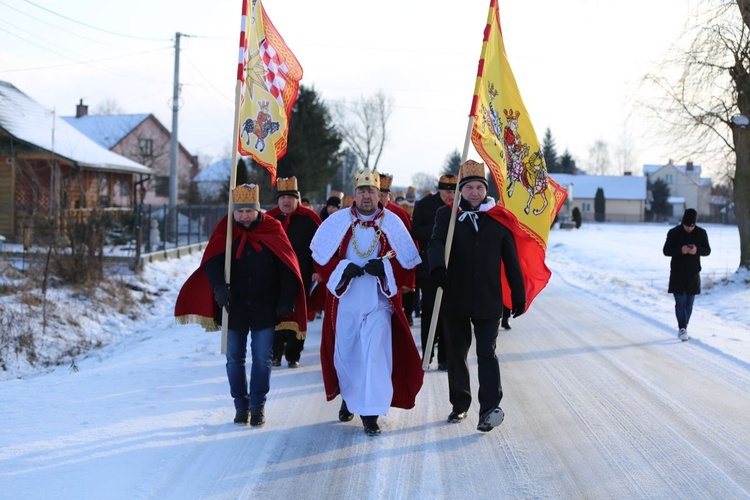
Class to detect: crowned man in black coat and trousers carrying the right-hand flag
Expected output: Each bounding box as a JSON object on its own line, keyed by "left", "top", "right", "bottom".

{"left": 427, "top": 160, "right": 526, "bottom": 432}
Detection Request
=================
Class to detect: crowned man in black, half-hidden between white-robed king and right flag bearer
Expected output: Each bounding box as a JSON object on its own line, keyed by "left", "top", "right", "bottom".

{"left": 411, "top": 174, "right": 457, "bottom": 370}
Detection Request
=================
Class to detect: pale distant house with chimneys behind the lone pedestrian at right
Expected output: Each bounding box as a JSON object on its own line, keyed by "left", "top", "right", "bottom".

{"left": 643, "top": 160, "right": 717, "bottom": 220}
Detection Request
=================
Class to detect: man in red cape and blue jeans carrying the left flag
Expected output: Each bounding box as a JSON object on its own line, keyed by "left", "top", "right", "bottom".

{"left": 175, "top": 184, "right": 307, "bottom": 426}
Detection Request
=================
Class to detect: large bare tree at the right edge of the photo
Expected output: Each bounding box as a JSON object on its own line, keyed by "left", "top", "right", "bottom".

{"left": 644, "top": 0, "right": 750, "bottom": 269}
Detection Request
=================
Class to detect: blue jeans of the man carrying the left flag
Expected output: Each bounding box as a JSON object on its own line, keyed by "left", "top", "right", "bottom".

{"left": 227, "top": 327, "right": 274, "bottom": 411}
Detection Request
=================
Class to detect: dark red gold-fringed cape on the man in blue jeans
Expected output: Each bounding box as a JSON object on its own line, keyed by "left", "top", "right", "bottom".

{"left": 174, "top": 215, "right": 307, "bottom": 334}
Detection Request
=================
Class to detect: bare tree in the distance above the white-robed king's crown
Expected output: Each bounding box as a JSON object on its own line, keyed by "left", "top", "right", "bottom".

{"left": 333, "top": 92, "right": 393, "bottom": 170}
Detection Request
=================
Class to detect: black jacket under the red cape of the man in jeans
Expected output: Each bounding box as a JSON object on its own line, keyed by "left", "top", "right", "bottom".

{"left": 203, "top": 214, "right": 298, "bottom": 331}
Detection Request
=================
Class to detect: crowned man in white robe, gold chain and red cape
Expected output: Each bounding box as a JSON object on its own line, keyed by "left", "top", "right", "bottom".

{"left": 310, "top": 169, "right": 424, "bottom": 436}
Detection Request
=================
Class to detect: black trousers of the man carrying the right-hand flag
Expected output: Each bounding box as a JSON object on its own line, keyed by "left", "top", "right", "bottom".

{"left": 443, "top": 313, "right": 503, "bottom": 415}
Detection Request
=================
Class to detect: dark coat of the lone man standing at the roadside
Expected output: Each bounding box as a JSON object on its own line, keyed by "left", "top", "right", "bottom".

{"left": 663, "top": 224, "right": 711, "bottom": 295}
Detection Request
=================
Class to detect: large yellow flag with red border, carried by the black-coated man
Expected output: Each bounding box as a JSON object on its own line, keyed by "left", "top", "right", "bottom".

{"left": 470, "top": 0, "right": 567, "bottom": 303}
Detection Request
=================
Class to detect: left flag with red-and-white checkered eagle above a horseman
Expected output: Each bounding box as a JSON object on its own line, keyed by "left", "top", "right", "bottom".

{"left": 237, "top": 0, "right": 302, "bottom": 185}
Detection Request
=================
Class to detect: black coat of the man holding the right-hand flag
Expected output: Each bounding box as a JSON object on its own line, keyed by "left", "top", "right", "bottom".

{"left": 427, "top": 200, "right": 526, "bottom": 319}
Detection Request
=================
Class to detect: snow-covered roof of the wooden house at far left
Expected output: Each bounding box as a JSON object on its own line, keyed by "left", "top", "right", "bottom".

{"left": 0, "top": 81, "right": 151, "bottom": 174}
